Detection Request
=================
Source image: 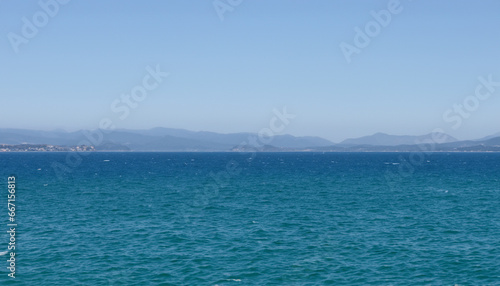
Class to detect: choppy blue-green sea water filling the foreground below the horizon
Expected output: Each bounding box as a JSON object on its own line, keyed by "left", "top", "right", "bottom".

{"left": 0, "top": 153, "right": 500, "bottom": 285}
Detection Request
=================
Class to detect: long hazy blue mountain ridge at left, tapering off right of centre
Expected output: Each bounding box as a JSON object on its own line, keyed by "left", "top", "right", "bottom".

{"left": 0, "top": 128, "right": 333, "bottom": 151}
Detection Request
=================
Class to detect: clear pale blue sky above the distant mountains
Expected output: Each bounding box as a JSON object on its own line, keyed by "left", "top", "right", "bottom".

{"left": 0, "top": 0, "right": 500, "bottom": 141}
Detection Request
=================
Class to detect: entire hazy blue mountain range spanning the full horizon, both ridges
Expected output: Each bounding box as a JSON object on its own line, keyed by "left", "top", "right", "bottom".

{"left": 0, "top": 127, "right": 500, "bottom": 152}
